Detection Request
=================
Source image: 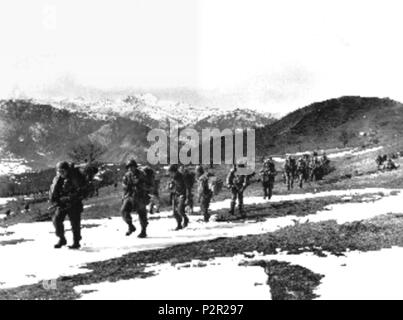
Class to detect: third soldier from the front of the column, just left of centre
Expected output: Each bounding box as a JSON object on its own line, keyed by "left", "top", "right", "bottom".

{"left": 168, "top": 164, "right": 189, "bottom": 230}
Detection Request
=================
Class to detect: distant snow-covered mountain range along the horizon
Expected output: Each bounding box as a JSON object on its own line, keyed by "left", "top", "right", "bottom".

{"left": 33, "top": 94, "right": 273, "bottom": 129}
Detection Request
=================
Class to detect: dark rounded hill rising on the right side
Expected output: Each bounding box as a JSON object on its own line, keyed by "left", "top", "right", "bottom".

{"left": 256, "top": 97, "right": 403, "bottom": 154}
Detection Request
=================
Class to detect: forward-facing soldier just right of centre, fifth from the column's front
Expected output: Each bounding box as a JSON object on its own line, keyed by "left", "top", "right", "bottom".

{"left": 227, "top": 163, "right": 249, "bottom": 218}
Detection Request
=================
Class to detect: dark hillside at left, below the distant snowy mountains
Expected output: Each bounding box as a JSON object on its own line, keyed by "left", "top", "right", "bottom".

{"left": 0, "top": 100, "right": 149, "bottom": 168}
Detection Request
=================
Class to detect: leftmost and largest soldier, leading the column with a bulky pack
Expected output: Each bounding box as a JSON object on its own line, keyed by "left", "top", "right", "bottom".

{"left": 49, "top": 161, "right": 83, "bottom": 249}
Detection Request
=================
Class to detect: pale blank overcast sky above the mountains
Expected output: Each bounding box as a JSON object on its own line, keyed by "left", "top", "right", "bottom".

{"left": 0, "top": 0, "right": 403, "bottom": 113}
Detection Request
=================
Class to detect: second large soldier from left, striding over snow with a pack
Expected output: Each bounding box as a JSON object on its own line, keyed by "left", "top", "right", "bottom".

{"left": 120, "top": 160, "right": 149, "bottom": 238}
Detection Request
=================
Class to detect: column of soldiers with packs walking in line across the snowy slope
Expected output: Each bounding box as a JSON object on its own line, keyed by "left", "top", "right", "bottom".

{"left": 50, "top": 155, "right": 328, "bottom": 249}
